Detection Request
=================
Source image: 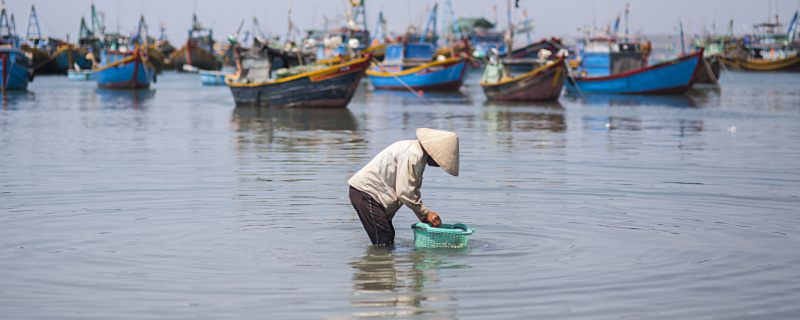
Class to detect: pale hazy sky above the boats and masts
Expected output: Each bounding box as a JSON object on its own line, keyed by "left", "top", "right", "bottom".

{"left": 5, "top": 0, "right": 800, "bottom": 43}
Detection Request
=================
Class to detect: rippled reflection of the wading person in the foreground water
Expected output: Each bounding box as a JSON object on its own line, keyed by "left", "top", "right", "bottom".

{"left": 350, "top": 246, "right": 468, "bottom": 319}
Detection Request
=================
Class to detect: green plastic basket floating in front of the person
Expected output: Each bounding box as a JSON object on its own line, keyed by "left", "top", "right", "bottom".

{"left": 411, "top": 222, "right": 475, "bottom": 248}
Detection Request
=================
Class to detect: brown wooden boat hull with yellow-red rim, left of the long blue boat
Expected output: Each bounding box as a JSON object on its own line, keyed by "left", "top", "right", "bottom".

{"left": 480, "top": 57, "right": 567, "bottom": 101}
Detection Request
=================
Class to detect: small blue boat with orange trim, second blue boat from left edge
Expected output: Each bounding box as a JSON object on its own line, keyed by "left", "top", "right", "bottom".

{"left": 92, "top": 47, "right": 156, "bottom": 89}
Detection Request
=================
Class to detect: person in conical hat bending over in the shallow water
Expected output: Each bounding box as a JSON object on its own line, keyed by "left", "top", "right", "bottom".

{"left": 347, "top": 128, "right": 458, "bottom": 245}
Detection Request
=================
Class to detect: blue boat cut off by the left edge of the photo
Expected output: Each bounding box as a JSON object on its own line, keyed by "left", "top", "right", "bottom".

{"left": 0, "top": 6, "right": 33, "bottom": 92}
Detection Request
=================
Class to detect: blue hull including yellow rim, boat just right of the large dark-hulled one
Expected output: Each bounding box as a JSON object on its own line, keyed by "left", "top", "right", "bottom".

{"left": 367, "top": 59, "right": 466, "bottom": 91}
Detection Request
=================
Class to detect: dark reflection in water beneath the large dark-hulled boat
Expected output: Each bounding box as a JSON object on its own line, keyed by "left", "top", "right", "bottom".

{"left": 231, "top": 106, "right": 363, "bottom": 147}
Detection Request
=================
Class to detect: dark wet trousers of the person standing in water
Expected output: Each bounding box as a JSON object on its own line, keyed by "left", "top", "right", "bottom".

{"left": 350, "top": 187, "right": 394, "bottom": 245}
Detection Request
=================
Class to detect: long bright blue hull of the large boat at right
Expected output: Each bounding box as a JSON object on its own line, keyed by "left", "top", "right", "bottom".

{"left": 567, "top": 50, "right": 703, "bottom": 94}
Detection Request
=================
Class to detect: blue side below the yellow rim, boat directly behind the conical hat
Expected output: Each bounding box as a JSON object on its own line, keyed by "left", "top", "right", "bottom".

{"left": 369, "top": 61, "right": 466, "bottom": 90}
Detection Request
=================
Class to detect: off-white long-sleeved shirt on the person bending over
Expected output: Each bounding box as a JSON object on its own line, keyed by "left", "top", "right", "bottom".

{"left": 347, "top": 140, "right": 428, "bottom": 220}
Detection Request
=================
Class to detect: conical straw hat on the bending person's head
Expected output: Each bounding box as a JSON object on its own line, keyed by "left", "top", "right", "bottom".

{"left": 417, "top": 128, "right": 458, "bottom": 176}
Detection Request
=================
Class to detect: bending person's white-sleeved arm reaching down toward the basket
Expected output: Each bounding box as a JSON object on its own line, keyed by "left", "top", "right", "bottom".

{"left": 395, "top": 155, "right": 428, "bottom": 221}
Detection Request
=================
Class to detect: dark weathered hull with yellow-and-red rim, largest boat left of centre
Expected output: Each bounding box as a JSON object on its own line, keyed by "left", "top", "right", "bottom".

{"left": 226, "top": 58, "right": 369, "bottom": 108}
